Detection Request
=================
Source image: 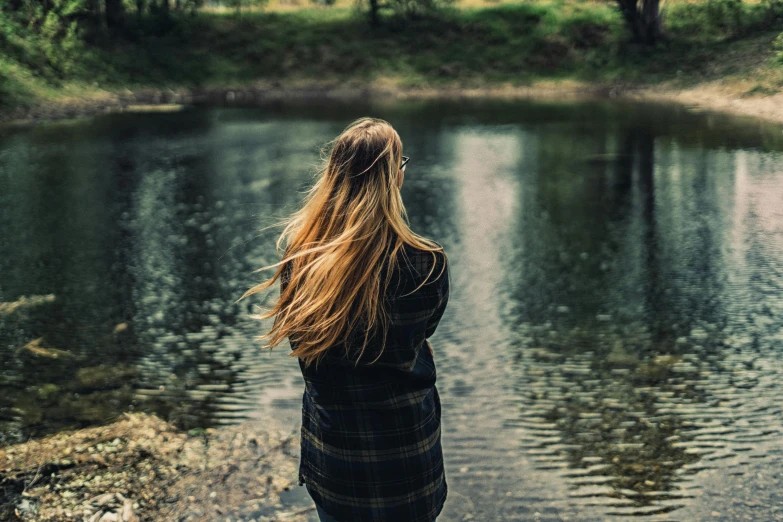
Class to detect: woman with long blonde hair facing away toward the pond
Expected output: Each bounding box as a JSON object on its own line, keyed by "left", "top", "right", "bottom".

{"left": 240, "top": 118, "right": 449, "bottom": 522}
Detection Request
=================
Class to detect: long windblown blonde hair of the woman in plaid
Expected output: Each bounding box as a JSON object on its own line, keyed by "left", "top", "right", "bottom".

{"left": 237, "top": 118, "right": 445, "bottom": 368}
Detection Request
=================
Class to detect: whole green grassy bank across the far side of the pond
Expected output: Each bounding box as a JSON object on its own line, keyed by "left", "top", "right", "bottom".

{"left": 0, "top": 0, "right": 783, "bottom": 119}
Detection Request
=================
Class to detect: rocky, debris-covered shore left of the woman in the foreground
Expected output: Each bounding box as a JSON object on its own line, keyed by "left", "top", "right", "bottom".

{"left": 0, "top": 413, "right": 315, "bottom": 522}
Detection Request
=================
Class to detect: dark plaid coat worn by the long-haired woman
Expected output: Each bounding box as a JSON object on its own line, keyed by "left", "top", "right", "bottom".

{"left": 280, "top": 245, "right": 449, "bottom": 522}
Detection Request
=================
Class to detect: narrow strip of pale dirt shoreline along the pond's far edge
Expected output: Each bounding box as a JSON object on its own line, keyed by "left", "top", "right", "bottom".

{"left": 0, "top": 81, "right": 783, "bottom": 126}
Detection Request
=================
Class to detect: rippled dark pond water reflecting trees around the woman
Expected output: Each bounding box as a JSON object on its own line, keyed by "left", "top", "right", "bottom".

{"left": 0, "top": 96, "right": 783, "bottom": 521}
